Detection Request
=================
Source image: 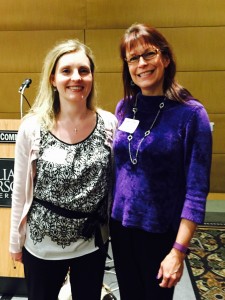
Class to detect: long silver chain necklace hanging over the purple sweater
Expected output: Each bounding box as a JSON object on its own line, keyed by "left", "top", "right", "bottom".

{"left": 127, "top": 96, "right": 165, "bottom": 165}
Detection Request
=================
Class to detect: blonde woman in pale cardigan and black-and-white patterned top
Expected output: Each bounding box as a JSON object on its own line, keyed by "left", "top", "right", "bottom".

{"left": 10, "top": 40, "right": 117, "bottom": 300}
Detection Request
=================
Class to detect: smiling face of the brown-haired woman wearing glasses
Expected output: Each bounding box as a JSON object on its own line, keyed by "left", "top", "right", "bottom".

{"left": 126, "top": 43, "right": 170, "bottom": 96}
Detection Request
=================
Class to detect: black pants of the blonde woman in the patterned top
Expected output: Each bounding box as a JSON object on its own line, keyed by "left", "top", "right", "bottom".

{"left": 23, "top": 245, "right": 108, "bottom": 300}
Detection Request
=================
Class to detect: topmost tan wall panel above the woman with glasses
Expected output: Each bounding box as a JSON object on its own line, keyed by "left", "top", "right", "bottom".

{"left": 87, "top": 0, "right": 225, "bottom": 29}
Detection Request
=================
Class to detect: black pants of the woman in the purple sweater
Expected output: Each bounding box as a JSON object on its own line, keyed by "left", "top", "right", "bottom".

{"left": 110, "top": 220, "right": 176, "bottom": 300}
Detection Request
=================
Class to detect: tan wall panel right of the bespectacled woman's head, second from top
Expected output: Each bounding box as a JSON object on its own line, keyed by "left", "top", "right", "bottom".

{"left": 160, "top": 27, "right": 225, "bottom": 71}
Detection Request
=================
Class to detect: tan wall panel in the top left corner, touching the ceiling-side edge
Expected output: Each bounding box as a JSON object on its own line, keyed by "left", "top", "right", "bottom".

{"left": 0, "top": 0, "right": 86, "bottom": 31}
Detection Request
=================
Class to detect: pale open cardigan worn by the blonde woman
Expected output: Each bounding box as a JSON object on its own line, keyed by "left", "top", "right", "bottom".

{"left": 9, "top": 109, "right": 117, "bottom": 253}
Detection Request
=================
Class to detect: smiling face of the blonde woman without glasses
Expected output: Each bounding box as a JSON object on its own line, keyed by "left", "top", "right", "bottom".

{"left": 51, "top": 51, "right": 93, "bottom": 102}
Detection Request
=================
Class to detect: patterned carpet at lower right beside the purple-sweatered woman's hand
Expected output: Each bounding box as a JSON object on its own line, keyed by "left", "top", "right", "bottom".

{"left": 186, "top": 223, "right": 225, "bottom": 300}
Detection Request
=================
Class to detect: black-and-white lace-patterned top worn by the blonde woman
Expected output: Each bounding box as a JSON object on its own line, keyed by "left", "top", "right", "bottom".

{"left": 25, "top": 115, "right": 111, "bottom": 256}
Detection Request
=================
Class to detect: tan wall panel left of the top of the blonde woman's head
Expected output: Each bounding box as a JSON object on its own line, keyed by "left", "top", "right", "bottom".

{"left": 0, "top": 30, "right": 84, "bottom": 73}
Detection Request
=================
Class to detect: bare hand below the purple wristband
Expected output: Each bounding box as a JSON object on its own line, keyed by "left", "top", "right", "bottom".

{"left": 157, "top": 249, "right": 185, "bottom": 288}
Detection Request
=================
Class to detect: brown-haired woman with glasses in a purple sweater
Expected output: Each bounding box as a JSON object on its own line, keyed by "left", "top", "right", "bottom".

{"left": 111, "top": 24, "right": 212, "bottom": 300}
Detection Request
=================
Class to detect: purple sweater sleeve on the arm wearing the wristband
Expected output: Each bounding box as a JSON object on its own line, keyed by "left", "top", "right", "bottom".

{"left": 181, "top": 105, "right": 212, "bottom": 224}
